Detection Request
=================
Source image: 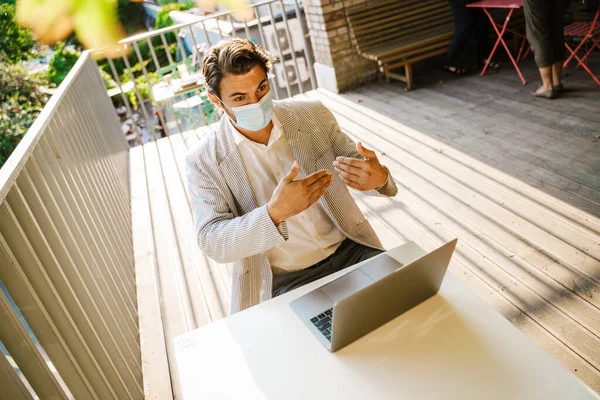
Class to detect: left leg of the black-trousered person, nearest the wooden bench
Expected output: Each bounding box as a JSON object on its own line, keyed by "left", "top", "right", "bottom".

{"left": 444, "top": 0, "right": 471, "bottom": 75}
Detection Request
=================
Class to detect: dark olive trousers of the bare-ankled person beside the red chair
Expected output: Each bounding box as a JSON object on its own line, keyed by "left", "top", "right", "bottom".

{"left": 523, "top": 0, "right": 565, "bottom": 68}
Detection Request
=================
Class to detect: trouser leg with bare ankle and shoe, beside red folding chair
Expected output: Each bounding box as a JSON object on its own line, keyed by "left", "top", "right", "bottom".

{"left": 523, "top": 0, "right": 556, "bottom": 99}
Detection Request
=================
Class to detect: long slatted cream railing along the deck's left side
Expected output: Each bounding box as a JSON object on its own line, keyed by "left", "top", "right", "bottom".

{"left": 0, "top": 52, "right": 143, "bottom": 400}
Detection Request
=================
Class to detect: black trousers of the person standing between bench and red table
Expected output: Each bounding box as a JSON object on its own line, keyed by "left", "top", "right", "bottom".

{"left": 447, "top": 0, "right": 491, "bottom": 68}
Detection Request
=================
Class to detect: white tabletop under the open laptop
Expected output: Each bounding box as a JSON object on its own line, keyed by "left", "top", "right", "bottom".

{"left": 176, "top": 244, "right": 600, "bottom": 400}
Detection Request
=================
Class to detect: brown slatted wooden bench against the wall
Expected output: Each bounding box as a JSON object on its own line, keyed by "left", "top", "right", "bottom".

{"left": 347, "top": 0, "right": 454, "bottom": 90}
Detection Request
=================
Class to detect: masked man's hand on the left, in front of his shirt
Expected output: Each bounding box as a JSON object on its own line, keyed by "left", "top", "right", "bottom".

{"left": 267, "top": 161, "right": 333, "bottom": 225}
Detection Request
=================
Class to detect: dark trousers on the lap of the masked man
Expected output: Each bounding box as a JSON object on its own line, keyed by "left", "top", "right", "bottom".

{"left": 273, "top": 239, "right": 383, "bottom": 297}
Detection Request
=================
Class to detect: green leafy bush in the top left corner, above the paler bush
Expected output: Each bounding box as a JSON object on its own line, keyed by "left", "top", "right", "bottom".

{"left": 0, "top": 2, "right": 35, "bottom": 64}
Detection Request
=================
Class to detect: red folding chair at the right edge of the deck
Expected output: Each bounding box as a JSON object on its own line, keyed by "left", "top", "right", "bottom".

{"left": 563, "top": 7, "right": 600, "bottom": 85}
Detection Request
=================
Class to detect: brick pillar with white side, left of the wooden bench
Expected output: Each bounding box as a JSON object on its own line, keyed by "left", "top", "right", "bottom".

{"left": 303, "top": 0, "right": 377, "bottom": 93}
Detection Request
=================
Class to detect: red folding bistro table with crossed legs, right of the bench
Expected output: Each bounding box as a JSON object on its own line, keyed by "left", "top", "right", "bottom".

{"left": 467, "top": 0, "right": 529, "bottom": 85}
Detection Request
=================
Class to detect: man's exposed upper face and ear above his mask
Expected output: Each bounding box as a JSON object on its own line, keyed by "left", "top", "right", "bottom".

{"left": 208, "top": 65, "right": 270, "bottom": 121}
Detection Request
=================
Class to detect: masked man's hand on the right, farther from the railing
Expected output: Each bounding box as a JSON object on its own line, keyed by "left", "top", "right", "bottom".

{"left": 333, "top": 142, "right": 388, "bottom": 191}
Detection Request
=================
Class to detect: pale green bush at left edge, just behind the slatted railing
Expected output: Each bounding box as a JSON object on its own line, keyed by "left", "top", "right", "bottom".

{"left": 0, "top": 56, "right": 48, "bottom": 167}
